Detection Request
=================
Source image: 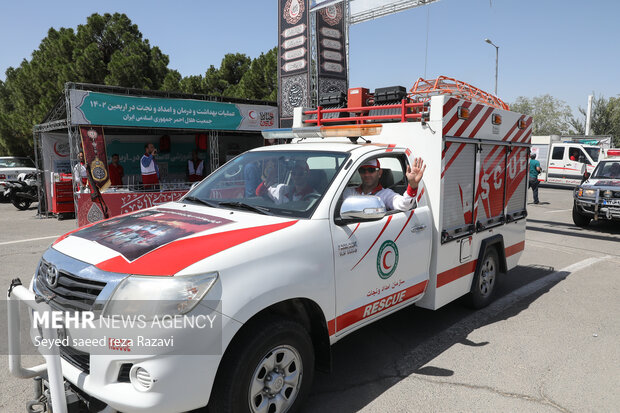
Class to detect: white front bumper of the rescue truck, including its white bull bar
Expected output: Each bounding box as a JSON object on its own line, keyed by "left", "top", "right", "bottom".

{"left": 8, "top": 248, "right": 241, "bottom": 413}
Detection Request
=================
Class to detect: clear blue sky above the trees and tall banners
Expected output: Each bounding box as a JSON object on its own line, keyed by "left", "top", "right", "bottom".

{"left": 0, "top": 0, "right": 620, "bottom": 118}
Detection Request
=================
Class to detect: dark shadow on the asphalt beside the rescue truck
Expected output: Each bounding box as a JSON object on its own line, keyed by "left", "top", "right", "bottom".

{"left": 302, "top": 266, "right": 568, "bottom": 413}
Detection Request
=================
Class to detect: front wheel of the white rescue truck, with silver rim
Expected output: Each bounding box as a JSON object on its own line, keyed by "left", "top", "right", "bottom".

{"left": 208, "top": 317, "right": 314, "bottom": 413}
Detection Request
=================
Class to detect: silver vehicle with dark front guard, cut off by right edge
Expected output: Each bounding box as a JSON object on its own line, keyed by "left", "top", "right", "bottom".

{"left": 573, "top": 157, "right": 620, "bottom": 227}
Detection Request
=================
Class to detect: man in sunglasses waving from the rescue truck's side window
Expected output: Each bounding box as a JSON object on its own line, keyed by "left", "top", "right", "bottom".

{"left": 344, "top": 158, "right": 426, "bottom": 211}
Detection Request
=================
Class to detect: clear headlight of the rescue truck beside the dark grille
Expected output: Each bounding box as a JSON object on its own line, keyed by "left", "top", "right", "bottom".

{"left": 103, "top": 272, "right": 218, "bottom": 317}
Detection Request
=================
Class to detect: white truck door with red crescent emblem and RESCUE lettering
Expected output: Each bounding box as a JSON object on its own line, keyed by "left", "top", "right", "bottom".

{"left": 331, "top": 153, "right": 432, "bottom": 335}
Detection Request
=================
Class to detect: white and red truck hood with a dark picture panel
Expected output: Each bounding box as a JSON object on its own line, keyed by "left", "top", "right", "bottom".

{"left": 53, "top": 203, "right": 297, "bottom": 275}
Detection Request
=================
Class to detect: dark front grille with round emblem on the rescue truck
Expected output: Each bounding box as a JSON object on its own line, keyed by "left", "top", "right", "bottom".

{"left": 36, "top": 260, "right": 106, "bottom": 311}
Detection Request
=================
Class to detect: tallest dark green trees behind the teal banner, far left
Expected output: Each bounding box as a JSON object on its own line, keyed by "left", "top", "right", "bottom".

{"left": 0, "top": 13, "right": 169, "bottom": 155}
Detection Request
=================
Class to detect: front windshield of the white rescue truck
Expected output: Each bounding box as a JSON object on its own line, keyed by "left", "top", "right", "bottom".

{"left": 182, "top": 151, "right": 349, "bottom": 218}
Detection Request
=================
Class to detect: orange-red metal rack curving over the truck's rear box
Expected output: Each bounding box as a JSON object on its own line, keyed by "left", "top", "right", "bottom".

{"left": 409, "top": 76, "right": 510, "bottom": 110}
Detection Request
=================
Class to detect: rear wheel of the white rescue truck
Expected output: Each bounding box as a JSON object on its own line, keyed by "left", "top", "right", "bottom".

{"left": 468, "top": 247, "right": 500, "bottom": 308}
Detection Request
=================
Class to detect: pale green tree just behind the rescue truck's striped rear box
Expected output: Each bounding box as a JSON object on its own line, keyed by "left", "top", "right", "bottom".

{"left": 510, "top": 95, "right": 575, "bottom": 135}
